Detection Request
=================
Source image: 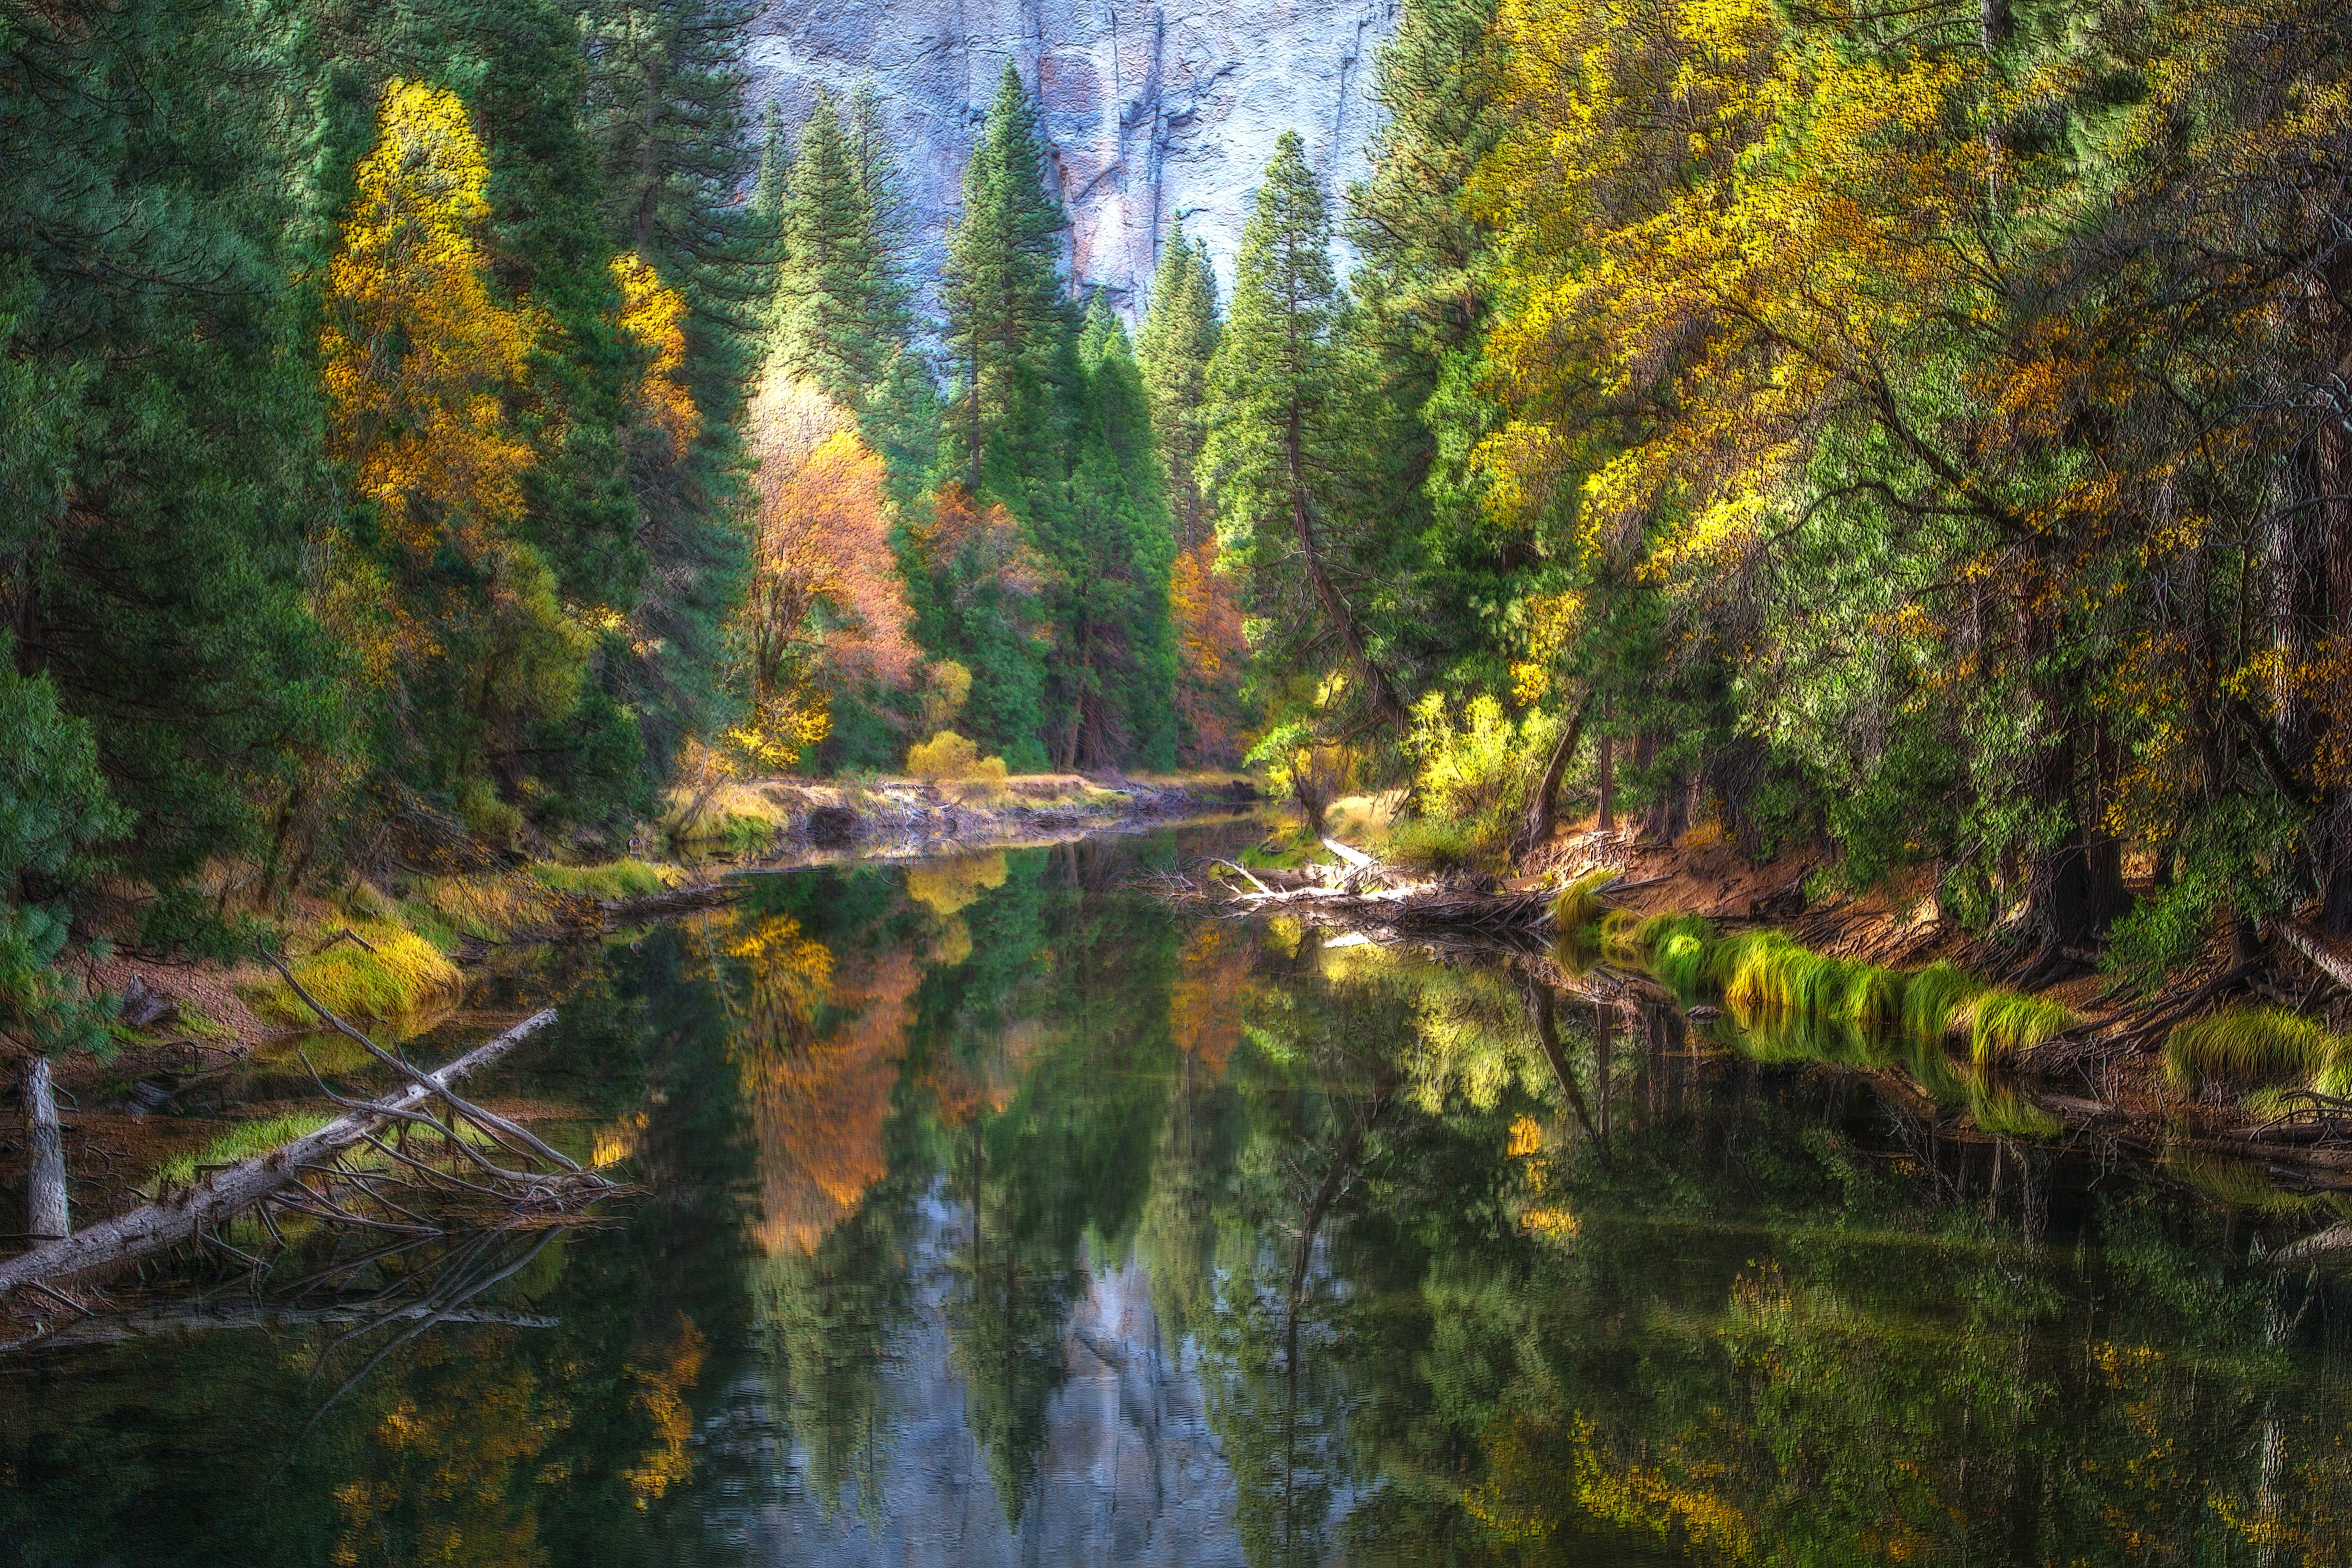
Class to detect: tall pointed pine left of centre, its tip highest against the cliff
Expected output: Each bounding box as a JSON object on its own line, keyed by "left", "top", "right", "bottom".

{"left": 943, "top": 61, "right": 1070, "bottom": 503}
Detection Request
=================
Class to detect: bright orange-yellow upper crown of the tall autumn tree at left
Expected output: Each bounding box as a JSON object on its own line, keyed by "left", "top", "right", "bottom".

{"left": 320, "top": 80, "right": 534, "bottom": 557}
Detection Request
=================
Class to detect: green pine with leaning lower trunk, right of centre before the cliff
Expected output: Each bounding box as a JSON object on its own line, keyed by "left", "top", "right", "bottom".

{"left": 1204, "top": 131, "right": 1411, "bottom": 736}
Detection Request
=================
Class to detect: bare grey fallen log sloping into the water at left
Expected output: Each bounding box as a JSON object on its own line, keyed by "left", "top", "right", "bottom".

{"left": 0, "top": 1009, "right": 555, "bottom": 1298}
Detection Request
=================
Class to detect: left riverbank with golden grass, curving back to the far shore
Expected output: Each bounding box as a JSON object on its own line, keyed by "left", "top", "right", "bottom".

{"left": 0, "top": 773, "right": 1258, "bottom": 1225}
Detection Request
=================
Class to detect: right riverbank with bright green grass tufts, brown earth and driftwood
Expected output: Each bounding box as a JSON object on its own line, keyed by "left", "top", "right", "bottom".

{"left": 1232, "top": 804, "right": 2352, "bottom": 1192}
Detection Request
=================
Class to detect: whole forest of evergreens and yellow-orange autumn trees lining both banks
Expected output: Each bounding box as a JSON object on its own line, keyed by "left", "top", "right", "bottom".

{"left": 13, "top": 0, "right": 2352, "bottom": 1081}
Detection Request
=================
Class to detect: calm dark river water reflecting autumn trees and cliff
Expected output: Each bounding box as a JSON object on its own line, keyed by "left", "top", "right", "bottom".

{"left": 0, "top": 825, "right": 2352, "bottom": 1568}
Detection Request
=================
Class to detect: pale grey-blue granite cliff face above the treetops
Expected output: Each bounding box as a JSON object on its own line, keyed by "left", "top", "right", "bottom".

{"left": 748, "top": 0, "right": 1397, "bottom": 317}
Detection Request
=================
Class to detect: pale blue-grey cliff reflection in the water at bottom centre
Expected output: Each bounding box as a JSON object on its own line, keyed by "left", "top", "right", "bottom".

{"left": 748, "top": 1189, "right": 1242, "bottom": 1568}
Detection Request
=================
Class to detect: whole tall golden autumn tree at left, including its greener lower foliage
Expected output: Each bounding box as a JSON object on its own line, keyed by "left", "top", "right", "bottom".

{"left": 318, "top": 80, "right": 588, "bottom": 822}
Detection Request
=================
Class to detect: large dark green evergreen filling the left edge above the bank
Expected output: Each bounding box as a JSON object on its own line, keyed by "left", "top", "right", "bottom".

{"left": 0, "top": 0, "right": 353, "bottom": 940}
